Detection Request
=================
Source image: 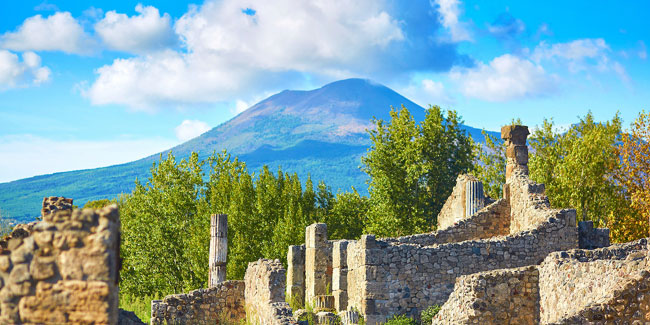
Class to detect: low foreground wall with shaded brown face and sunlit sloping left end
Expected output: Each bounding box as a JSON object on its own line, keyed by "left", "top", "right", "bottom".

{"left": 433, "top": 266, "right": 539, "bottom": 324}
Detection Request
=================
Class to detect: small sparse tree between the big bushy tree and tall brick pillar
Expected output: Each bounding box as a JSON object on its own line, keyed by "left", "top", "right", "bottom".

{"left": 472, "top": 130, "right": 506, "bottom": 199}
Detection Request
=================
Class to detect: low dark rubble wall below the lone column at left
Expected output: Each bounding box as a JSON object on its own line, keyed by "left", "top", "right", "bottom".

{"left": 151, "top": 281, "right": 246, "bottom": 324}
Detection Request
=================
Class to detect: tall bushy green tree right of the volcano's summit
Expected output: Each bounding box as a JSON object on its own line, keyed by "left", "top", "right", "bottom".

{"left": 362, "top": 106, "right": 473, "bottom": 236}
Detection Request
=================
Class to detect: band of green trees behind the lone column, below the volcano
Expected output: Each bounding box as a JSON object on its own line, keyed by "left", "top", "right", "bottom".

{"left": 118, "top": 152, "right": 368, "bottom": 295}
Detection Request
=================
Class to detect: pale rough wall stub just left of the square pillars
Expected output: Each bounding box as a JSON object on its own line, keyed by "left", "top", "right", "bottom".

{"left": 244, "top": 259, "right": 296, "bottom": 325}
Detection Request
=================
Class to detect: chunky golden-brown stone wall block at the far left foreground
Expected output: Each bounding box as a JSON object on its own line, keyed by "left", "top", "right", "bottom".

{"left": 0, "top": 204, "right": 120, "bottom": 324}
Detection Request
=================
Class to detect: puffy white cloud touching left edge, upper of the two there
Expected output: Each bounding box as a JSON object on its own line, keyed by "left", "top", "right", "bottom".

{"left": 0, "top": 12, "right": 96, "bottom": 54}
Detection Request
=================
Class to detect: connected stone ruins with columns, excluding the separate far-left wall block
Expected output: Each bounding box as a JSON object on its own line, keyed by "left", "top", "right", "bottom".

{"left": 152, "top": 126, "right": 650, "bottom": 324}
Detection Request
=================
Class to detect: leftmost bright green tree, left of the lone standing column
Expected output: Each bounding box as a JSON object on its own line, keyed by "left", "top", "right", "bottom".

{"left": 120, "top": 152, "right": 207, "bottom": 295}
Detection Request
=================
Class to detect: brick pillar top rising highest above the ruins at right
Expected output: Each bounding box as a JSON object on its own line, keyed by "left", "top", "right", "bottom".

{"left": 501, "top": 125, "right": 530, "bottom": 181}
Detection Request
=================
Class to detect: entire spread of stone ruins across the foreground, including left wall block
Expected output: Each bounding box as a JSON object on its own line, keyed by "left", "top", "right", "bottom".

{"left": 0, "top": 126, "right": 650, "bottom": 324}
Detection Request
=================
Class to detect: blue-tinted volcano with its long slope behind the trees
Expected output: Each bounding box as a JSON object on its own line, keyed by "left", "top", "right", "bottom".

{"left": 0, "top": 79, "right": 494, "bottom": 220}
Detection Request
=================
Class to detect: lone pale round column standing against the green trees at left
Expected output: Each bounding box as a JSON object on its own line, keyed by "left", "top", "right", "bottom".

{"left": 208, "top": 214, "right": 228, "bottom": 288}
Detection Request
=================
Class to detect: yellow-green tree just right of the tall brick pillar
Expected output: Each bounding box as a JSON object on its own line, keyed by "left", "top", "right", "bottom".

{"left": 528, "top": 112, "right": 627, "bottom": 226}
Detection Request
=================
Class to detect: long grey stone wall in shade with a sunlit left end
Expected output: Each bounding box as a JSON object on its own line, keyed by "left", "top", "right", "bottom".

{"left": 347, "top": 210, "right": 578, "bottom": 324}
